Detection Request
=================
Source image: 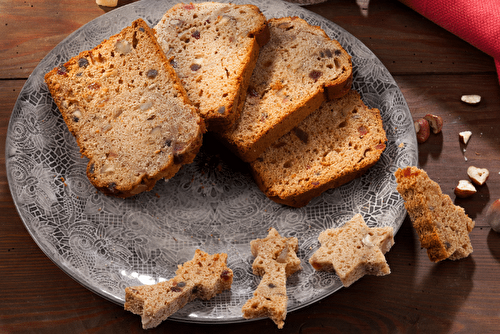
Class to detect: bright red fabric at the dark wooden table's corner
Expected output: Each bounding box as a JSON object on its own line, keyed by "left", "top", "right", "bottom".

{"left": 400, "top": 0, "right": 500, "bottom": 82}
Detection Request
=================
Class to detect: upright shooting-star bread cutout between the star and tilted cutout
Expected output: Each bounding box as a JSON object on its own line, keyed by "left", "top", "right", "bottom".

{"left": 242, "top": 228, "right": 301, "bottom": 329}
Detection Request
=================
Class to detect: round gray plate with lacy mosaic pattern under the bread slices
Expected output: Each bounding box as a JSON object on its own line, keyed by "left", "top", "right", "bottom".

{"left": 6, "top": 0, "right": 417, "bottom": 323}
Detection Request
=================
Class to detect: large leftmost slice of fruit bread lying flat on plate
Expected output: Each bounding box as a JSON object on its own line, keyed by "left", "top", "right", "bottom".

{"left": 45, "top": 19, "right": 204, "bottom": 197}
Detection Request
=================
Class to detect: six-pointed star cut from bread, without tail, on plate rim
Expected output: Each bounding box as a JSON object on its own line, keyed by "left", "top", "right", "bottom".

{"left": 309, "top": 213, "right": 394, "bottom": 287}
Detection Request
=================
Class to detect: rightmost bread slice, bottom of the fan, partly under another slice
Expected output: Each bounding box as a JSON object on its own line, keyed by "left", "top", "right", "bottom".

{"left": 250, "top": 90, "right": 387, "bottom": 207}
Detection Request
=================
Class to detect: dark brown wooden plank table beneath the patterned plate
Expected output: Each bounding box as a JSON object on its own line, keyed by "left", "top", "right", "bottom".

{"left": 0, "top": 0, "right": 500, "bottom": 334}
